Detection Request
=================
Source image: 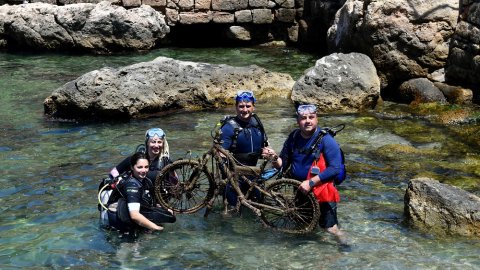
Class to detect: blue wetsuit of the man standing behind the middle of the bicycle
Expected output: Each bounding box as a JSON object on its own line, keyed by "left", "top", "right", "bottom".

{"left": 221, "top": 117, "right": 267, "bottom": 205}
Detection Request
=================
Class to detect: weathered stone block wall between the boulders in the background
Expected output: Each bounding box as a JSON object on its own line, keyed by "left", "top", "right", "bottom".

{"left": 0, "top": 0, "right": 308, "bottom": 43}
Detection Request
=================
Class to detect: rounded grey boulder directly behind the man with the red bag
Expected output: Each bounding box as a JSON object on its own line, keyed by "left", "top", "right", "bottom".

{"left": 292, "top": 53, "right": 380, "bottom": 112}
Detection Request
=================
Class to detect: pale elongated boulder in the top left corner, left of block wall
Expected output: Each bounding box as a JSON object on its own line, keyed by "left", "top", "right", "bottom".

{"left": 0, "top": 1, "right": 170, "bottom": 54}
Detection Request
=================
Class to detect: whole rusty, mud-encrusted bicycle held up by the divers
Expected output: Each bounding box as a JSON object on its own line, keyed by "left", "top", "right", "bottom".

{"left": 155, "top": 125, "right": 320, "bottom": 233}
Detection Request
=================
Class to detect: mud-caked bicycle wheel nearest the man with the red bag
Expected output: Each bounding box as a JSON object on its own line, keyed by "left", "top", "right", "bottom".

{"left": 261, "top": 179, "right": 320, "bottom": 234}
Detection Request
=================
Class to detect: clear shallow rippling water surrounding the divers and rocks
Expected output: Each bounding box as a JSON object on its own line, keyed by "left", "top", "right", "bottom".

{"left": 0, "top": 48, "right": 480, "bottom": 269}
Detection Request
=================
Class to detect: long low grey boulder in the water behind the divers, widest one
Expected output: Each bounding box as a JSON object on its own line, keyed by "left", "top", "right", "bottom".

{"left": 44, "top": 57, "right": 295, "bottom": 120}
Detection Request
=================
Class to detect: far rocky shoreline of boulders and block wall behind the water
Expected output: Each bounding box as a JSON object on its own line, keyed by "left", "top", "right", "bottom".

{"left": 0, "top": 0, "right": 480, "bottom": 110}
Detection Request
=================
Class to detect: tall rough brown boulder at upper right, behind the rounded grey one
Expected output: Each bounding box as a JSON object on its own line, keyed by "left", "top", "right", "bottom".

{"left": 328, "top": 0, "right": 459, "bottom": 94}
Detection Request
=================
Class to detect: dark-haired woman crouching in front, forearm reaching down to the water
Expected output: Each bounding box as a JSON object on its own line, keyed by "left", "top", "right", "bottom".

{"left": 100, "top": 152, "right": 176, "bottom": 232}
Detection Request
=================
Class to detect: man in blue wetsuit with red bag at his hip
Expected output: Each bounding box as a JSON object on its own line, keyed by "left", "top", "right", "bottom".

{"left": 262, "top": 104, "right": 347, "bottom": 245}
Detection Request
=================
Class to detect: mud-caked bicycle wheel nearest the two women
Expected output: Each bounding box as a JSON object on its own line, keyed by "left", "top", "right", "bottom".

{"left": 155, "top": 160, "right": 215, "bottom": 214}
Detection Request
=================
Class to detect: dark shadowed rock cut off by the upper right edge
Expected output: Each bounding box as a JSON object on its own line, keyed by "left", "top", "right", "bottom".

{"left": 445, "top": 1, "right": 480, "bottom": 100}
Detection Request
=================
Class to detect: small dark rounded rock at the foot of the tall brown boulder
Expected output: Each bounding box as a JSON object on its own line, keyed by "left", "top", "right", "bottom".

{"left": 398, "top": 78, "right": 446, "bottom": 104}
